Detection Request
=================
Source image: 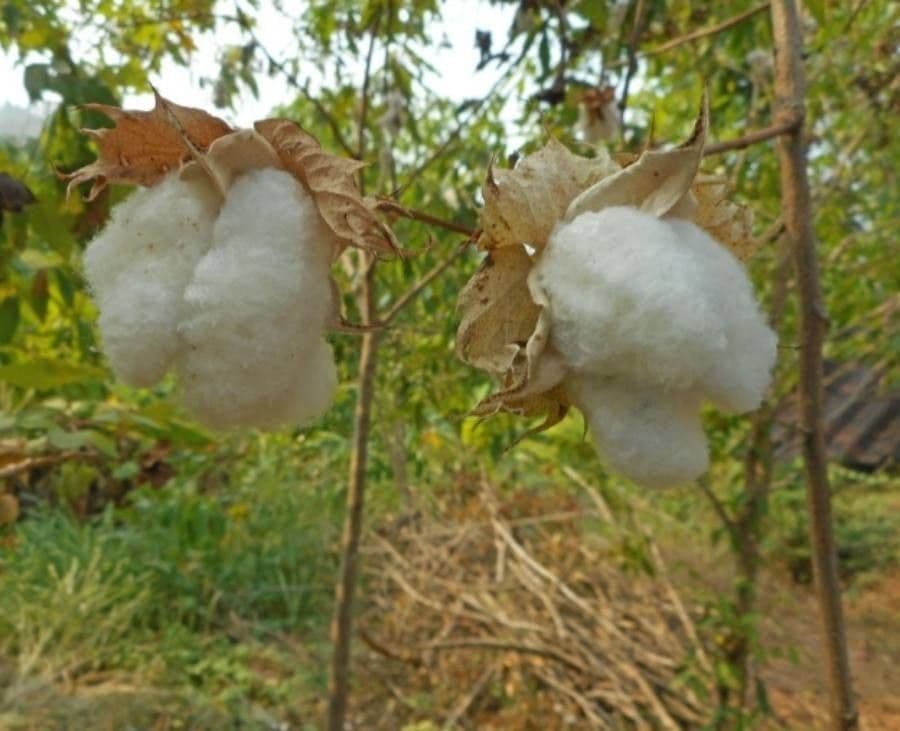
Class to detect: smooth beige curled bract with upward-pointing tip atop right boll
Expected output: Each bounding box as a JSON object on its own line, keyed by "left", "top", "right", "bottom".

{"left": 565, "top": 95, "right": 709, "bottom": 221}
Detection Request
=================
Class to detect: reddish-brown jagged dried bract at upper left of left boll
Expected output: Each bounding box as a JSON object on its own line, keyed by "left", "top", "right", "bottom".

{"left": 65, "top": 94, "right": 231, "bottom": 200}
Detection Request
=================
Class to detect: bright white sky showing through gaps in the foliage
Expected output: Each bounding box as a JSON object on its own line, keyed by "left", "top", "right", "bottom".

{"left": 0, "top": 0, "right": 513, "bottom": 135}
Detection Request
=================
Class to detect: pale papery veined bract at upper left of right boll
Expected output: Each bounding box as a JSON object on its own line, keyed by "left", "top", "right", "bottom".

{"left": 479, "top": 138, "right": 619, "bottom": 249}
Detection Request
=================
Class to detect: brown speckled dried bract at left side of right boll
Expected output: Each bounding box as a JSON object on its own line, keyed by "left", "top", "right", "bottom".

{"left": 456, "top": 246, "right": 541, "bottom": 374}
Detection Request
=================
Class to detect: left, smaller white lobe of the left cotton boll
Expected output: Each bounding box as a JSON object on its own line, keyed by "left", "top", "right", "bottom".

{"left": 84, "top": 173, "right": 216, "bottom": 386}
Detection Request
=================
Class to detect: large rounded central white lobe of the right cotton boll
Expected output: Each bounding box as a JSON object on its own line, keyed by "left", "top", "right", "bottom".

{"left": 533, "top": 207, "right": 728, "bottom": 389}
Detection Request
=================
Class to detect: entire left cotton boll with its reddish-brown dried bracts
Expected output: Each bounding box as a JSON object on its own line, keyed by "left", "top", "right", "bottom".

{"left": 70, "top": 97, "right": 396, "bottom": 429}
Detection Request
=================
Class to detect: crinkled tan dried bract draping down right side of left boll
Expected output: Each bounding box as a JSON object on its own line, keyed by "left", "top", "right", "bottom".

{"left": 254, "top": 119, "right": 398, "bottom": 254}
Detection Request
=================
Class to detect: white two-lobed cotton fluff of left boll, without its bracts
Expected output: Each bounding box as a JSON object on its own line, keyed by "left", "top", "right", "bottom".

{"left": 85, "top": 168, "right": 337, "bottom": 429}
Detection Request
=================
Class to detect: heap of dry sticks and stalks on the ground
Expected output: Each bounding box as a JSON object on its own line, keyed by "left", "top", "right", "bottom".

{"left": 356, "top": 483, "right": 709, "bottom": 729}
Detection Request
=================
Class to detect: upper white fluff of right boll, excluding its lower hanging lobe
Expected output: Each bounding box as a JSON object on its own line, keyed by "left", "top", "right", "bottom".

{"left": 535, "top": 208, "right": 776, "bottom": 412}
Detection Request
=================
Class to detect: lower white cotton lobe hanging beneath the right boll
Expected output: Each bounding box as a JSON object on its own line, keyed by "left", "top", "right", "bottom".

{"left": 566, "top": 377, "right": 709, "bottom": 487}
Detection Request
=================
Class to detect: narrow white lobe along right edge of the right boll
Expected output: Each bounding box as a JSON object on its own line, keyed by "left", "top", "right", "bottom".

{"left": 669, "top": 220, "right": 777, "bottom": 413}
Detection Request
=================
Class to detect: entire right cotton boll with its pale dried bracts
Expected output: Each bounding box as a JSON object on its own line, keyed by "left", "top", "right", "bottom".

{"left": 457, "top": 97, "right": 776, "bottom": 486}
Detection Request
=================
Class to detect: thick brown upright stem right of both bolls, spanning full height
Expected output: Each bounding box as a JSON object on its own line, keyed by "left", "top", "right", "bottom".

{"left": 771, "top": 0, "right": 859, "bottom": 731}
